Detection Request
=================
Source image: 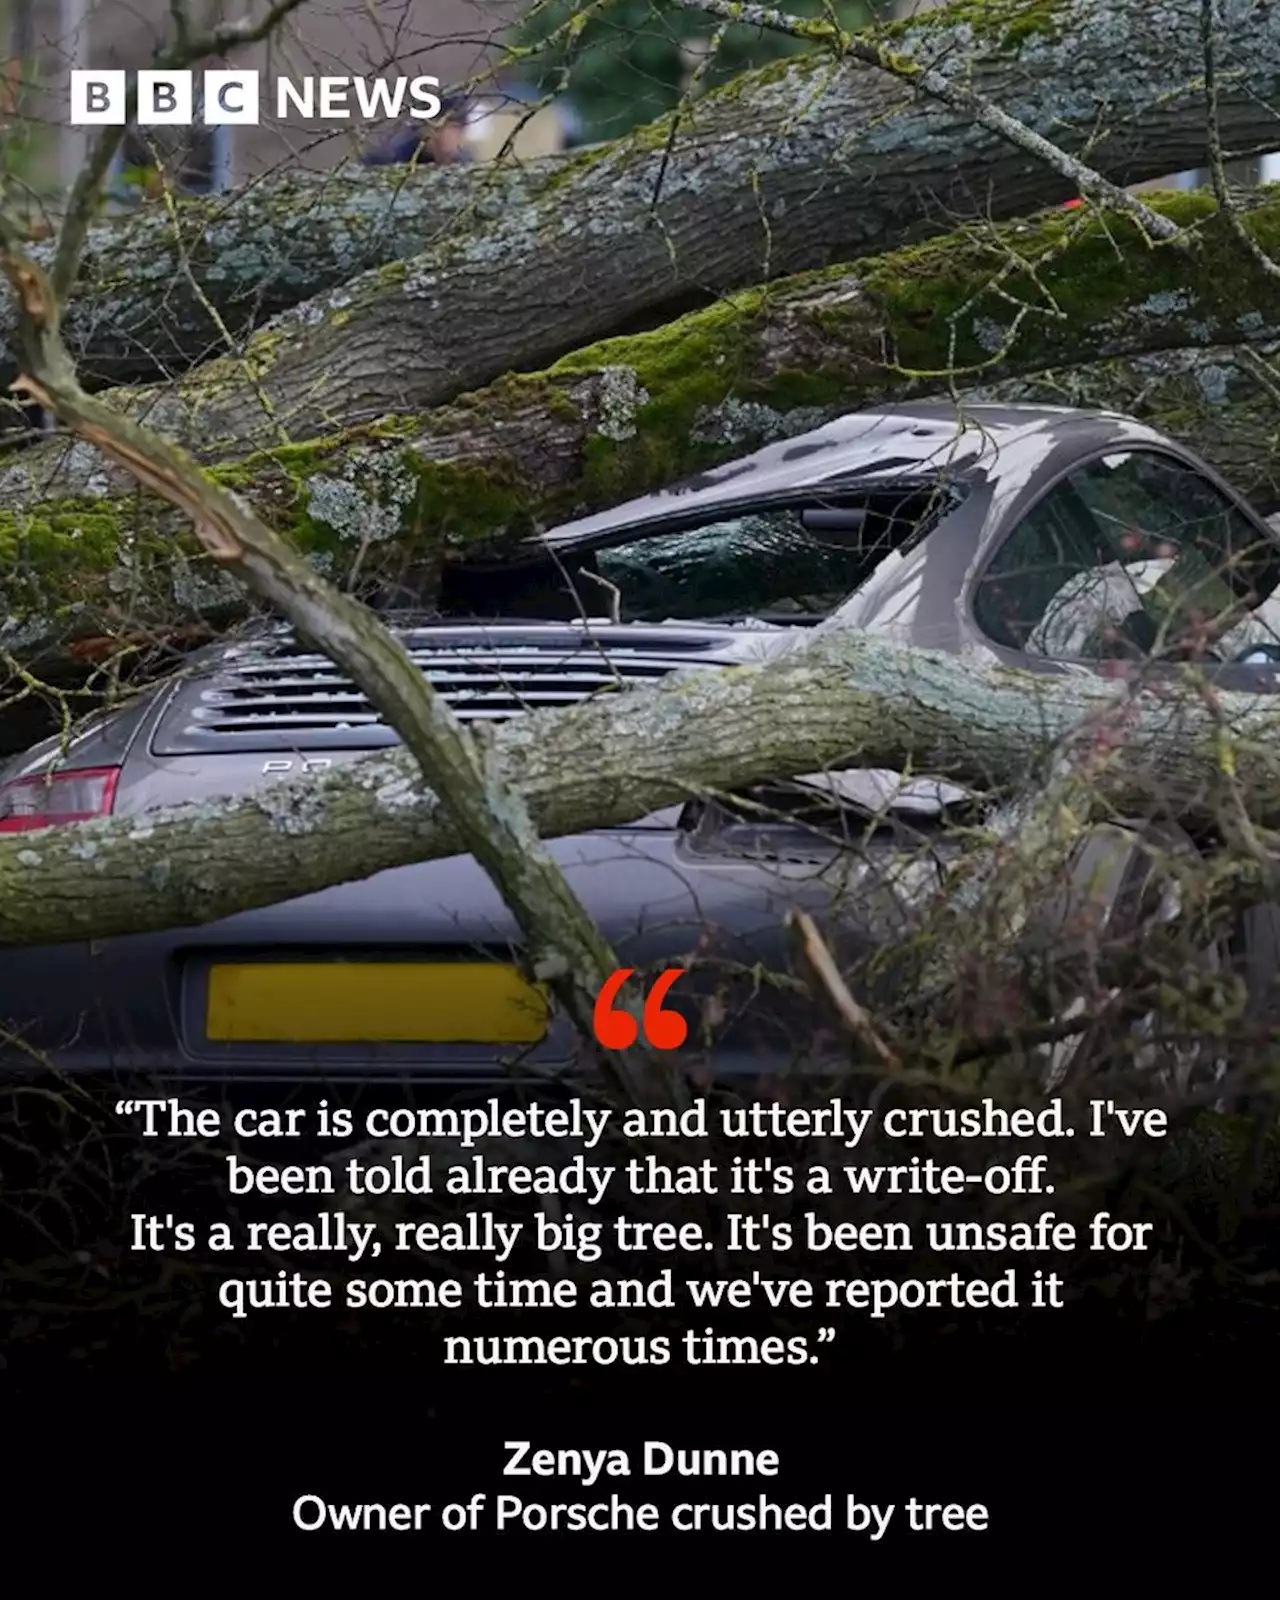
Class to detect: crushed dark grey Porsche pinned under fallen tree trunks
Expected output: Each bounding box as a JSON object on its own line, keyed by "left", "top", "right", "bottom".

{"left": 0, "top": 403, "right": 1280, "bottom": 1083}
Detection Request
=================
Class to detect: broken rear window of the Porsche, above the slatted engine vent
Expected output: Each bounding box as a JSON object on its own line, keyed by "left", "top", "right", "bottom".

{"left": 440, "top": 482, "right": 958, "bottom": 624}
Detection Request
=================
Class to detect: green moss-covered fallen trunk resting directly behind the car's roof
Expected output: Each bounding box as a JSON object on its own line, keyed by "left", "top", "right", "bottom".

{"left": 0, "top": 190, "right": 1280, "bottom": 672}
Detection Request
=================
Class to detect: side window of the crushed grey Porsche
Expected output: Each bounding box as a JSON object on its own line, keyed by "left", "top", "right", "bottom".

{"left": 974, "top": 450, "right": 1277, "bottom": 661}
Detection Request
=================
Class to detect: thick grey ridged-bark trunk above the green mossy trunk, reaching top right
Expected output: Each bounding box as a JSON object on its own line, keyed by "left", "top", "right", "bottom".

{"left": 10, "top": 0, "right": 1280, "bottom": 458}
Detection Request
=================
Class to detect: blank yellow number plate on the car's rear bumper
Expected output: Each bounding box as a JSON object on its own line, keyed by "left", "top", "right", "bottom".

{"left": 205, "top": 962, "right": 549, "bottom": 1045}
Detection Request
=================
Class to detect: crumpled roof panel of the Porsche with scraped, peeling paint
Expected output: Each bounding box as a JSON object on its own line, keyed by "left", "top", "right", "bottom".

{"left": 544, "top": 400, "right": 1155, "bottom": 544}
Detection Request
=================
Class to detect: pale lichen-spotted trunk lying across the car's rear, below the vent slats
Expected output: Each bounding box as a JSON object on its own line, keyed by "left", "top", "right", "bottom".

{"left": 0, "top": 630, "right": 1280, "bottom": 946}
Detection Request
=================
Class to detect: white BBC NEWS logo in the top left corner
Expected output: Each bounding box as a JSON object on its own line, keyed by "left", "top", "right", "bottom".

{"left": 70, "top": 70, "right": 443, "bottom": 128}
